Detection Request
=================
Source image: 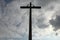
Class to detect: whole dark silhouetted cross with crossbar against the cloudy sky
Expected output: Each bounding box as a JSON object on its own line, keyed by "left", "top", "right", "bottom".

{"left": 20, "top": 2, "right": 41, "bottom": 40}
